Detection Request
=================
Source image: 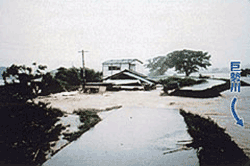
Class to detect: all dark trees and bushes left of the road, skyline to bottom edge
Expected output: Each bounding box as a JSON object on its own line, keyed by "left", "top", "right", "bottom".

{"left": 0, "top": 63, "right": 101, "bottom": 165}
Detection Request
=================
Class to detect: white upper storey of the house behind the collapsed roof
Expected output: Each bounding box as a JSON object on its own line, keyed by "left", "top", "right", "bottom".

{"left": 102, "top": 59, "right": 143, "bottom": 79}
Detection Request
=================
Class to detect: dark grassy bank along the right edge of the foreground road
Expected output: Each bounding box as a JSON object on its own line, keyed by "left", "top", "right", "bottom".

{"left": 180, "top": 109, "right": 249, "bottom": 166}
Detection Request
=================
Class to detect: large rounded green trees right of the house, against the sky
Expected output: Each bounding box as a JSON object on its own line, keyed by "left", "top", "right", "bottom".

{"left": 146, "top": 49, "right": 211, "bottom": 76}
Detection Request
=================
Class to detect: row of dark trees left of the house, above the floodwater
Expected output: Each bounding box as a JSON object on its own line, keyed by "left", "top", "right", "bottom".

{"left": 0, "top": 63, "right": 102, "bottom": 102}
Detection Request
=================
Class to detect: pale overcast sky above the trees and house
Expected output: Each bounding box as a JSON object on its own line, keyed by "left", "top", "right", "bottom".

{"left": 0, "top": 0, "right": 250, "bottom": 70}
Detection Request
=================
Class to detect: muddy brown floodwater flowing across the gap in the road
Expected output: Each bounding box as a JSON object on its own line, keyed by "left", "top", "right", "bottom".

{"left": 39, "top": 81, "right": 250, "bottom": 165}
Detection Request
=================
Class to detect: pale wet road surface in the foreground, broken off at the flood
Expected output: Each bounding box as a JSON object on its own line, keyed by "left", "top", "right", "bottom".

{"left": 44, "top": 107, "right": 199, "bottom": 166}
